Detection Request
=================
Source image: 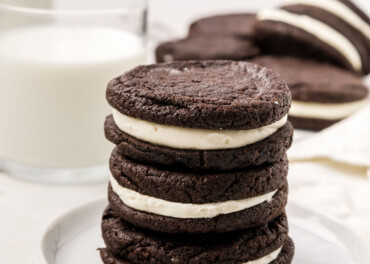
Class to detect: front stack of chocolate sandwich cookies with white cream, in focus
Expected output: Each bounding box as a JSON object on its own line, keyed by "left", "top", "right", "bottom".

{"left": 100, "top": 61, "right": 294, "bottom": 264}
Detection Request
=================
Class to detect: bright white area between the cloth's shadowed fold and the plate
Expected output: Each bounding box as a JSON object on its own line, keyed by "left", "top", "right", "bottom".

{"left": 288, "top": 159, "right": 370, "bottom": 242}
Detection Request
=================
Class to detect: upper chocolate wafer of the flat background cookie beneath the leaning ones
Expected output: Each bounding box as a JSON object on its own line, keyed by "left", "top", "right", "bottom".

{"left": 252, "top": 56, "right": 368, "bottom": 103}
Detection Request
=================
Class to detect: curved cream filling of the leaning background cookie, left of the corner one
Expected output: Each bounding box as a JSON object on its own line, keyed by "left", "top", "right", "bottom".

{"left": 257, "top": 9, "right": 362, "bottom": 71}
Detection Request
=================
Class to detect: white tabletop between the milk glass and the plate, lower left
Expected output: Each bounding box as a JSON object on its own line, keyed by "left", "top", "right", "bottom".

{"left": 0, "top": 173, "right": 107, "bottom": 264}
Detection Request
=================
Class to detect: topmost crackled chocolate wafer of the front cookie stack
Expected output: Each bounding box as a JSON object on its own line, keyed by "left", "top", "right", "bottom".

{"left": 107, "top": 61, "right": 291, "bottom": 130}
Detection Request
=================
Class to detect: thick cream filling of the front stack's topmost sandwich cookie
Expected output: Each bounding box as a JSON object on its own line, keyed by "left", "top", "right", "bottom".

{"left": 113, "top": 109, "right": 287, "bottom": 150}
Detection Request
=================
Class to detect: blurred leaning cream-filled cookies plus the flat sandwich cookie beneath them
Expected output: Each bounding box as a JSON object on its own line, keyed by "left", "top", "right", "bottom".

{"left": 254, "top": 0, "right": 370, "bottom": 130}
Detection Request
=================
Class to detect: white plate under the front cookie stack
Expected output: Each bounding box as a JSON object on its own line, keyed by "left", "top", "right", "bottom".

{"left": 41, "top": 199, "right": 370, "bottom": 264}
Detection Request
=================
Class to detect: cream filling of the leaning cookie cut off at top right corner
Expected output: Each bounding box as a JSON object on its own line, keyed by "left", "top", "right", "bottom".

{"left": 285, "top": 0, "right": 370, "bottom": 40}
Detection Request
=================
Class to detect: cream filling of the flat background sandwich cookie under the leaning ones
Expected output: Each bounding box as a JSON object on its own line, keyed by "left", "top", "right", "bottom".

{"left": 289, "top": 100, "right": 368, "bottom": 120}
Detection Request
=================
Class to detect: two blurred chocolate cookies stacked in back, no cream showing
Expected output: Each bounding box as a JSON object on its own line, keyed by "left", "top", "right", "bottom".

{"left": 155, "top": 14, "right": 260, "bottom": 62}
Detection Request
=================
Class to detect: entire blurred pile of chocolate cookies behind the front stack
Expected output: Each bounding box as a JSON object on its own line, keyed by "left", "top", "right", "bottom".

{"left": 156, "top": 0, "right": 370, "bottom": 131}
